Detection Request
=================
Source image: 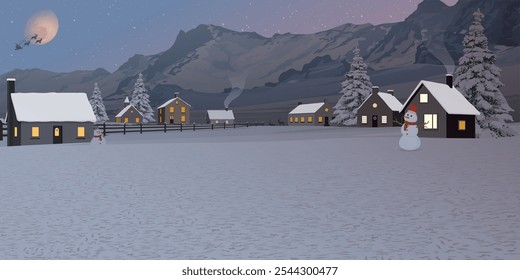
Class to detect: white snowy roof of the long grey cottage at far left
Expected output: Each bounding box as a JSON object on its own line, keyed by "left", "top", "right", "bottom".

{"left": 11, "top": 92, "right": 96, "bottom": 122}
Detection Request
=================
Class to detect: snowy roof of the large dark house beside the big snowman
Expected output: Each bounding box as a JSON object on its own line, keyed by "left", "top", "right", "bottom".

{"left": 401, "top": 81, "right": 480, "bottom": 116}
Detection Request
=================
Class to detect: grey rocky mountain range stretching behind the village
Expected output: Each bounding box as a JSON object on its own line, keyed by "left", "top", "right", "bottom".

{"left": 0, "top": 0, "right": 520, "bottom": 119}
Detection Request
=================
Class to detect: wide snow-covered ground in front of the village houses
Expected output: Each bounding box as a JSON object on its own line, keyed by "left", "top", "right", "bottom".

{"left": 0, "top": 125, "right": 520, "bottom": 259}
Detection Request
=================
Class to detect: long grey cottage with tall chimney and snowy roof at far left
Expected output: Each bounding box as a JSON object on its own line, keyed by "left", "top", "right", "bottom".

{"left": 7, "top": 79, "right": 96, "bottom": 146}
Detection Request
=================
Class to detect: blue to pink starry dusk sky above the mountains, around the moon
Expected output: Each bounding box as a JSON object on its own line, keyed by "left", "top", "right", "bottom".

{"left": 0, "top": 0, "right": 457, "bottom": 73}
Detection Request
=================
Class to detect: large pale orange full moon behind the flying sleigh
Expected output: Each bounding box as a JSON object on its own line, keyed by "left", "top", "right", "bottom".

{"left": 25, "top": 10, "right": 59, "bottom": 45}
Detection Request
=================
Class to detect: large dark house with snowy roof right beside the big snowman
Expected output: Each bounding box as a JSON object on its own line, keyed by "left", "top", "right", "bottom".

{"left": 401, "top": 75, "right": 480, "bottom": 138}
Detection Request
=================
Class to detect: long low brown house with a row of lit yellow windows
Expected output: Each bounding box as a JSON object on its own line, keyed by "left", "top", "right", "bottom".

{"left": 289, "top": 101, "right": 332, "bottom": 126}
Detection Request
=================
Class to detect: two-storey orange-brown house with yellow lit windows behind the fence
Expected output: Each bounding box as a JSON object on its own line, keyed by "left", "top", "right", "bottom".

{"left": 157, "top": 92, "right": 191, "bottom": 124}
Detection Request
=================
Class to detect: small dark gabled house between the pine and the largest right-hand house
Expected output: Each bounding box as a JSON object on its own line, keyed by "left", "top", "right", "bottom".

{"left": 357, "top": 86, "right": 403, "bottom": 127}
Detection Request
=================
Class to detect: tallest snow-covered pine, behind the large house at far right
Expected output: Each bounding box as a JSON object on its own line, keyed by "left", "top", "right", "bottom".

{"left": 455, "top": 9, "right": 516, "bottom": 137}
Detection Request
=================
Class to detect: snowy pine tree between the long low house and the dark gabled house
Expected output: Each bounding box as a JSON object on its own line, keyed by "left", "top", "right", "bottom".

{"left": 331, "top": 47, "right": 372, "bottom": 126}
